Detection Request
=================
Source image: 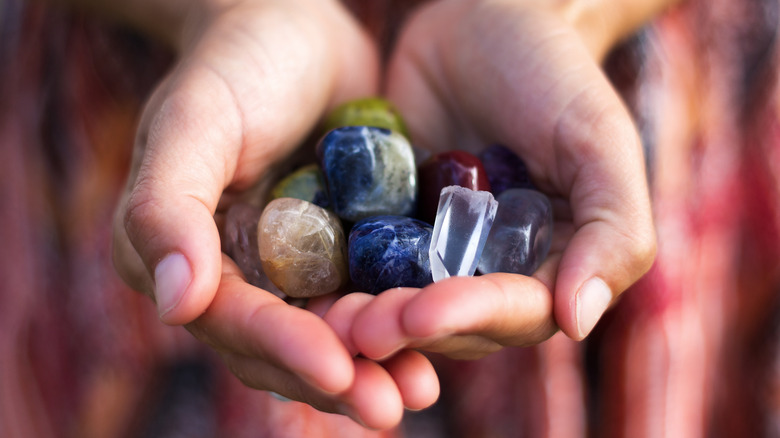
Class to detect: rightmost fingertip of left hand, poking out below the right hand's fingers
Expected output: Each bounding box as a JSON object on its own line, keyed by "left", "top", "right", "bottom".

{"left": 382, "top": 350, "right": 439, "bottom": 411}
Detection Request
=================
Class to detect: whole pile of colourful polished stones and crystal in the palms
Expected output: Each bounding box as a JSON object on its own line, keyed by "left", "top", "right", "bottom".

{"left": 223, "top": 98, "right": 552, "bottom": 297}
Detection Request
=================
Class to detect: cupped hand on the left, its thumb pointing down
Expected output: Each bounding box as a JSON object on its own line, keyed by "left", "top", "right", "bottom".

{"left": 114, "top": 0, "right": 438, "bottom": 428}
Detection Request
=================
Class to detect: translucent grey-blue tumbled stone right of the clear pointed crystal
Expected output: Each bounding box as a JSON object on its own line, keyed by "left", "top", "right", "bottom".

{"left": 478, "top": 189, "right": 553, "bottom": 275}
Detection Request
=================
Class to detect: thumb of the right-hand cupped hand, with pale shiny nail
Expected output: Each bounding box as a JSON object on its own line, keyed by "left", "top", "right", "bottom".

{"left": 554, "top": 96, "right": 656, "bottom": 340}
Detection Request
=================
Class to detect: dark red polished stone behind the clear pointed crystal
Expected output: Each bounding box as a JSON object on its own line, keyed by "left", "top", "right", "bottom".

{"left": 417, "top": 151, "right": 490, "bottom": 223}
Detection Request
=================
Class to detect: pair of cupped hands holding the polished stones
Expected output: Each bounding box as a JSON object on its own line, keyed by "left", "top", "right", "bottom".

{"left": 114, "top": 0, "right": 655, "bottom": 429}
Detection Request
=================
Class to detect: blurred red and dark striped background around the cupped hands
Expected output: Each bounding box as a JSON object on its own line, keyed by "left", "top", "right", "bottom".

{"left": 0, "top": 0, "right": 780, "bottom": 438}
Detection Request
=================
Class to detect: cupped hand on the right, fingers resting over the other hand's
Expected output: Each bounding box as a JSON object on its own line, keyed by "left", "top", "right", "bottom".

{"left": 344, "top": 0, "right": 655, "bottom": 359}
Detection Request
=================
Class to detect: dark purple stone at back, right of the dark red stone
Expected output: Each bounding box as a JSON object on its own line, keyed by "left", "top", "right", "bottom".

{"left": 479, "top": 144, "right": 535, "bottom": 196}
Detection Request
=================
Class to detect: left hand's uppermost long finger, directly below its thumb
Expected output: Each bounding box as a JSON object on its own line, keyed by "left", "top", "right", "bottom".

{"left": 187, "top": 255, "right": 354, "bottom": 394}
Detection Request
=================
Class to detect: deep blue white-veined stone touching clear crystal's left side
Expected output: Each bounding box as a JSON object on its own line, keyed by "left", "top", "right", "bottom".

{"left": 348, "top": 216, "right": 433, "bottom": 294}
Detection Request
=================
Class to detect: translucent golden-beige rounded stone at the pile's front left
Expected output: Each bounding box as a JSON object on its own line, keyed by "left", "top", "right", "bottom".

{"left": 257, "top": 198, "right": 349, "bottom": 298}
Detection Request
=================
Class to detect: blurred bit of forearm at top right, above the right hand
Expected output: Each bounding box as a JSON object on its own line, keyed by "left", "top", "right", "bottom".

{"left": 556, "top": 0, "right": 683, "bottom": 60}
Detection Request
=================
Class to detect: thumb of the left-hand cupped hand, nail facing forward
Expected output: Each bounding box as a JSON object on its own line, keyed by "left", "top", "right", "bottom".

{"left": 115, "top": 72, "right": 242, "bottom": 324}
